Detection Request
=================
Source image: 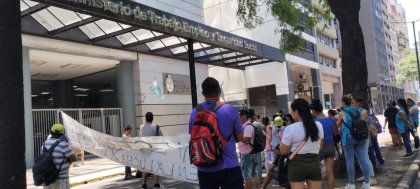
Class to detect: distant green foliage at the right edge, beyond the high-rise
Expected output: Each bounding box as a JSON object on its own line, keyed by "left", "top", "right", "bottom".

{"left": 397, "top": 52, "right": 419, "bottom": 84}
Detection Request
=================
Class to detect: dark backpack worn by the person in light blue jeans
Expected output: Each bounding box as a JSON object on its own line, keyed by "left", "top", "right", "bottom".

{"left": 343, "top": 109, "right": 369, "bottom": 140}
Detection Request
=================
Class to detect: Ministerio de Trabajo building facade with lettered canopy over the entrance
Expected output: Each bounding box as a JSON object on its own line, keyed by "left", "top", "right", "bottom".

{"left": 20, "top": 0, "right": 288, "bottom": 167}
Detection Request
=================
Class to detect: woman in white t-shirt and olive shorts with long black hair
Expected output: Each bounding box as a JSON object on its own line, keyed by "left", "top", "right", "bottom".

{"left": 280, "top": 98, "right": 324, "bottom": 189}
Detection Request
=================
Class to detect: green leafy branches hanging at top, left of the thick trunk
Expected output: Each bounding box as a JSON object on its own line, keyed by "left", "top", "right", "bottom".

{"left": 236, "top": 0, "right": 331, "bottom": 52}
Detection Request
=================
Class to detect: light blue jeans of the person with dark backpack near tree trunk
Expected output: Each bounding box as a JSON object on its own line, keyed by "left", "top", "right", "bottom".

{"left": 343, "top": 136, "right": 372, "bottom": 183}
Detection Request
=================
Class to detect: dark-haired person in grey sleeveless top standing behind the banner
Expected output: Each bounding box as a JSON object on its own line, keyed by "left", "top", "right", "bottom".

{"left": 139, "top": 112, "right": 160, "bottom": 188}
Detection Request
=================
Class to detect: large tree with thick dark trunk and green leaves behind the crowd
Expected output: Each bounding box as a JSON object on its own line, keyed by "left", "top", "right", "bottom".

{"left": 237, "top": 0, "right": 368, "bottom": 99}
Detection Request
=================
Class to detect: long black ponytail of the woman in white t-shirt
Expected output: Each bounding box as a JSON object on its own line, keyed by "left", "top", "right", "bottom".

{"left": 291, "top": 98, "right": 319, "bottom": 142}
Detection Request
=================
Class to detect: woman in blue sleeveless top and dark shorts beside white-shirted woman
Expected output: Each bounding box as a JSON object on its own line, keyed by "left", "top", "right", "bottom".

{"left": 310, "top": 99, "right": 335, "bottom": 189}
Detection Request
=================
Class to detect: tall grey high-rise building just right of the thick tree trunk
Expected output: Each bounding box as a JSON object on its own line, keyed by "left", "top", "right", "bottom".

{"left": 359, "top": 0, "right": 403, "bottom": 113}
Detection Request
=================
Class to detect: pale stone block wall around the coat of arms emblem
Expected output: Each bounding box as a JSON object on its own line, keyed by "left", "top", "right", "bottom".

{"left": 133, "top": 54, "right": 208, "bottom": 135}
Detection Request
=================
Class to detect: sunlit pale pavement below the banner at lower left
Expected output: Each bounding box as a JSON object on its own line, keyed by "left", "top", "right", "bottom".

{"left": 26, "top": 158, "right": 124, "bottom": 188}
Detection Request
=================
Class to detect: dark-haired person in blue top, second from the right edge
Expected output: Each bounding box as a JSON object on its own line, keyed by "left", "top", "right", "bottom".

{"left": 396, "top": 98, "right": 413, "bottom": 158}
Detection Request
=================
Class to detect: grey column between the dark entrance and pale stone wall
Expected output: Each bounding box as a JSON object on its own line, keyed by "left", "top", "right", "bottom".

{"left": 117, "top": 60, "right": 137, "bottom": 136}
